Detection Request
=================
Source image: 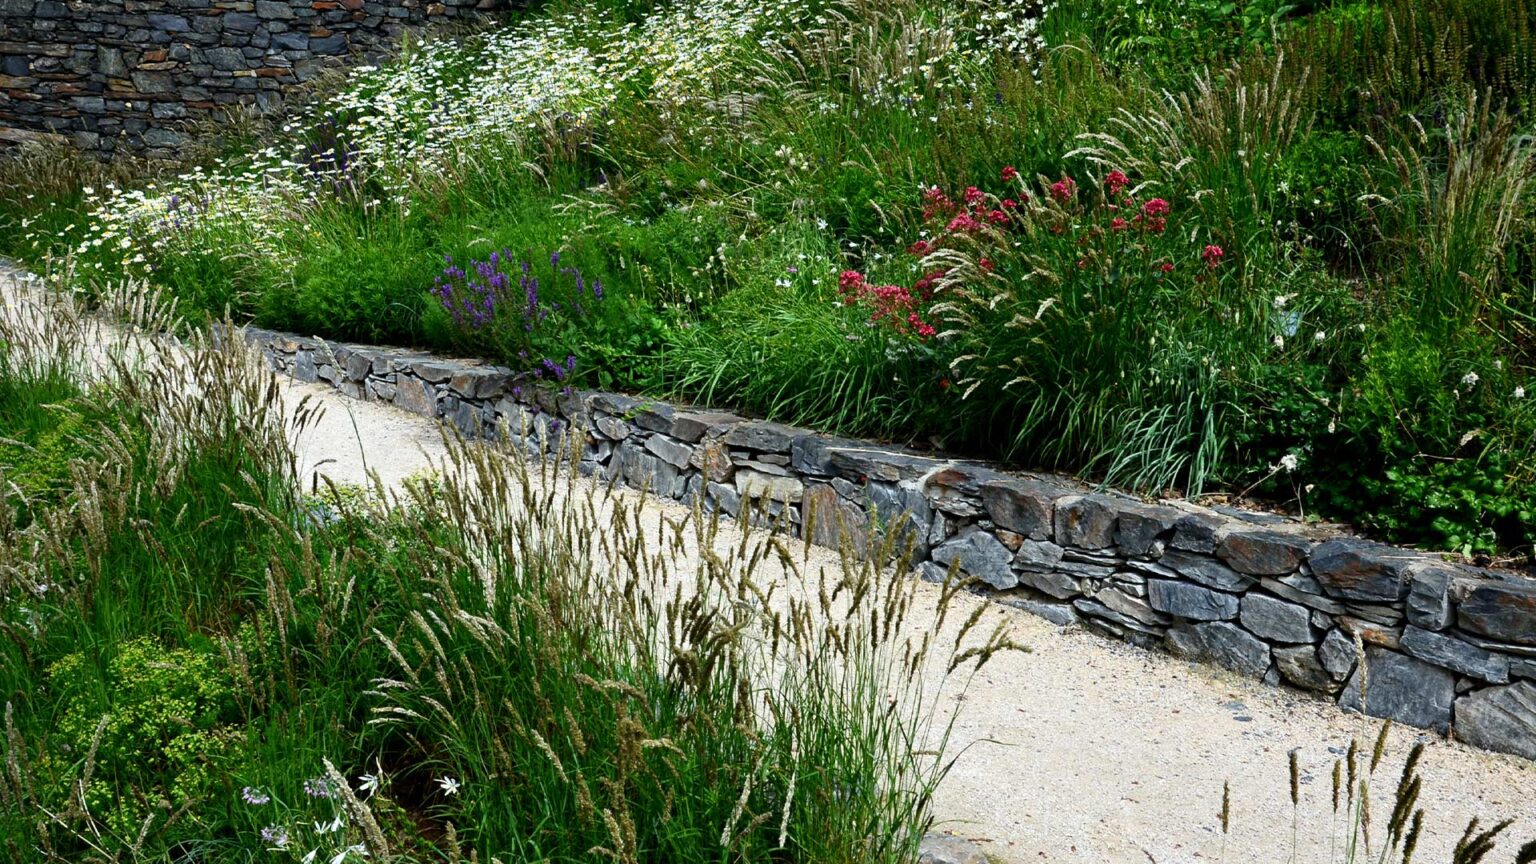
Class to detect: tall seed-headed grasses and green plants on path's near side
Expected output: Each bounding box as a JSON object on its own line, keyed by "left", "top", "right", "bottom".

{"left": 0, "top": 287, "right": 1008, "bottom": 864}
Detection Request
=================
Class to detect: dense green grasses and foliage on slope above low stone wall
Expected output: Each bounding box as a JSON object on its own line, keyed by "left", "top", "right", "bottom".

{"left": 0, "top": 0, "right": 1536, "bottom": 555}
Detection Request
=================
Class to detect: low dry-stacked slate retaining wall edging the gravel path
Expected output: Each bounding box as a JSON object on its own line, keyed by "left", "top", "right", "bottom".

{"left": 247, "top": 324, "right": 1536, "bottom": 759}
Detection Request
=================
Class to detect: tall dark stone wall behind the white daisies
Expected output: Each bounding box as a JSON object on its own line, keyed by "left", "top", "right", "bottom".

{"left": 0, "top": 0, "right": 521, "bottom": 157}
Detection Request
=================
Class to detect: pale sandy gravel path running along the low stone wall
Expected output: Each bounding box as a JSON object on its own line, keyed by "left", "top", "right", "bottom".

{"left": 0, "top": 266, "right": 1536, "bottom": 862}
